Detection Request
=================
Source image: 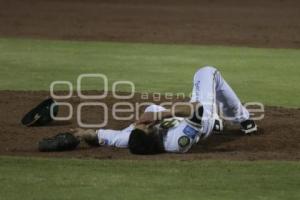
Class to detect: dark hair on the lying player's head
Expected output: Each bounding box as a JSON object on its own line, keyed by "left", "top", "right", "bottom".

{"left": 128, "top": 129, "right": 164, "bottom": 155}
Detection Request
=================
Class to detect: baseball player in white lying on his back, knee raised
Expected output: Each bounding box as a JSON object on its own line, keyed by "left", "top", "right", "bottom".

{"left": 69, "top": 67, "right": 257, "bottom": 154}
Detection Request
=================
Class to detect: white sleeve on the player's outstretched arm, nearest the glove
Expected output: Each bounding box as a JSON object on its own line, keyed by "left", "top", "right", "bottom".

{"left": 97, "top": 125, "right": 134, "bottom": 148}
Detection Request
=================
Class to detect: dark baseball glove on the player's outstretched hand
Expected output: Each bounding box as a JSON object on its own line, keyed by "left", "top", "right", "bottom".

{"left": 39, "top": 133, "right": 80, "bottom": 152}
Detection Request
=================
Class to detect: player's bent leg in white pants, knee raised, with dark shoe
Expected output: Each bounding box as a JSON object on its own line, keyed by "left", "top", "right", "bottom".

{"left": 191, "top": 66, "right": 257, "bottom": 133}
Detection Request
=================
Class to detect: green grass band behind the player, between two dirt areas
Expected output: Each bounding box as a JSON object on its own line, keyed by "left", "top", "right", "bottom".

{"left": 0, "top": 39, "right": 300, "bottom": 107}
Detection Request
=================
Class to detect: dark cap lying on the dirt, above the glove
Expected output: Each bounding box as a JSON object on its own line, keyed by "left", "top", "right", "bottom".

{"left": 22, "top": 98, "right": 58, "bottom": 126}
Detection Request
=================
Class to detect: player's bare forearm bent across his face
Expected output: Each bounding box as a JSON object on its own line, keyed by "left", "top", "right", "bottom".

{"left": 136, "top": 102, "right": 201, "bottom": 124}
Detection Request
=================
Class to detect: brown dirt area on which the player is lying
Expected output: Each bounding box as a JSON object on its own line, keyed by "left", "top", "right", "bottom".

{"left": 0, "top": 91, "right": 300, "bottom": 160}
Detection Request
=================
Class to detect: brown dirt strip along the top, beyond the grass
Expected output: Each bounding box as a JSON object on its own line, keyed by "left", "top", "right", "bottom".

{"left": 0, "top": 0, "right": 300, "bottom": 48}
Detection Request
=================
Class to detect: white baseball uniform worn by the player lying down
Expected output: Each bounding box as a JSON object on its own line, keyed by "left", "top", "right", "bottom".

{"left": 97, "top": 66, "right": 249, "bottom": 153}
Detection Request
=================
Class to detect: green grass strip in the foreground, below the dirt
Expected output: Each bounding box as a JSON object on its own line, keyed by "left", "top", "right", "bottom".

{"left": 0, "top": 157, "right": 300, "bottom": 200}
